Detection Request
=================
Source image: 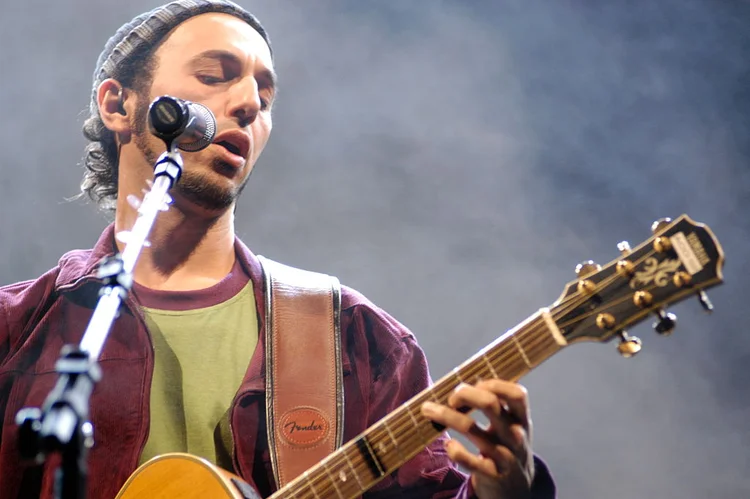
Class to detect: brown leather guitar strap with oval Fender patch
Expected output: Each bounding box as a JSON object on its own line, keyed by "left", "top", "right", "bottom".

{"left": 259, "top": 256, "right": 344, "bottom": 488}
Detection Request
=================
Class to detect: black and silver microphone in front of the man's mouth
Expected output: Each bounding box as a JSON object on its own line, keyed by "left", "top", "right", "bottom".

{"left": 148, "top": 95, "right": 216, "bottom": 152}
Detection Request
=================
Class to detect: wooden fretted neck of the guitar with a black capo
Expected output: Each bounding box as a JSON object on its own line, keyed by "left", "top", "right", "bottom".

{"left": 271, "top": 309, "right": 566, "bottom": 499}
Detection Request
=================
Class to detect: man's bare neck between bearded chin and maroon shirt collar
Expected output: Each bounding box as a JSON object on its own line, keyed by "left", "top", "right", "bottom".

{"left": 115, "top": 196, "right": 235, "bottom": 291}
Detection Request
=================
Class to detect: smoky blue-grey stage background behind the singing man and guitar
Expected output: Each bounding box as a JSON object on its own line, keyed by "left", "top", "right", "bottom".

{"left": 0, "top": 0, "right": 750, "bottom": 499}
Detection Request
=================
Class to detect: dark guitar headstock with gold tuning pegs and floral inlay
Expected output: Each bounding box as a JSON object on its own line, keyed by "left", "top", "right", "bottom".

{"left": 550, "top": 215, "right": 724, "bottom": 357}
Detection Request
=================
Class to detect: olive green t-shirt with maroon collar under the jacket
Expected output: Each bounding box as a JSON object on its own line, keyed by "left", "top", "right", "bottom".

{"left": 135, "top": 265, "right": 258, "bottom": 471}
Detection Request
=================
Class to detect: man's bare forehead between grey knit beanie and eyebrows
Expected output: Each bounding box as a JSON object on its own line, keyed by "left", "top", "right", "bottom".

{"left": 156, "top": 13, "right": 273, "bottom": 68}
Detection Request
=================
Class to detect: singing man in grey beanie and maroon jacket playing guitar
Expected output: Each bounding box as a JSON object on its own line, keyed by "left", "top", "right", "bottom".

{"left": 0, "top": 0, "right": 555, "bottom": 499}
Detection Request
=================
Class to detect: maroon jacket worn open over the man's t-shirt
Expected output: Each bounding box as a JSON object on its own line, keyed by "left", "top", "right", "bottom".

{"left": 0, "top": 225, "right": 555, "bottom": 499}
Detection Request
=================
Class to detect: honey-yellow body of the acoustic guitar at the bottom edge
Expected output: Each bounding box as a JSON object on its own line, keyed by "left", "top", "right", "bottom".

{"left": 116, "top": 453, "right": 260, "bottom": 499}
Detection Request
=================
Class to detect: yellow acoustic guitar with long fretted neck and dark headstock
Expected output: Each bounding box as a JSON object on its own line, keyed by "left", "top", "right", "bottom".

{"left": 117, "top": 215, "right": 724, "bottom": 499}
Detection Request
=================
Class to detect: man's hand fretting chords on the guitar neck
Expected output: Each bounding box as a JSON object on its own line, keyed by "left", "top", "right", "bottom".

{"left": 422, "top": 379, "right": 534, "bottom": 499}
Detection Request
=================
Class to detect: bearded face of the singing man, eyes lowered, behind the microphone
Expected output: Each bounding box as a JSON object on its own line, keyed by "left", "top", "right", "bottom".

{"left": 132, "top": 13, "right": 275, "bottom": 212}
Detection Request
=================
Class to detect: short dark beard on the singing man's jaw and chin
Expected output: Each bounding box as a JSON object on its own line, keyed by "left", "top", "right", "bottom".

{"left": 131, "top": 100, "right": 250, "bottom": 211}
